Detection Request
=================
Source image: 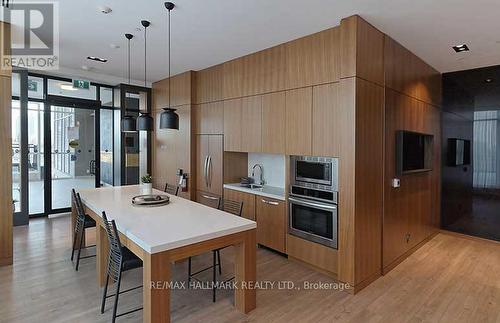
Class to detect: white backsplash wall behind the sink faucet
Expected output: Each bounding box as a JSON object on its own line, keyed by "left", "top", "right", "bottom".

{"left": 248, "top": 153, "right": 286, "bottom": 188}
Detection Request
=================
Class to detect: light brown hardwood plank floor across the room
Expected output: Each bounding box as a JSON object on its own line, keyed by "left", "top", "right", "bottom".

{"left": 0, "top": 217, "right": 500, "bottom": 322}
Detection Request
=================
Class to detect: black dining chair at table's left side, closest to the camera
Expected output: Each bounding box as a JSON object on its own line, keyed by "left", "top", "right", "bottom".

{"left": 101, "top": 212, "right": 142, "bottom": 323}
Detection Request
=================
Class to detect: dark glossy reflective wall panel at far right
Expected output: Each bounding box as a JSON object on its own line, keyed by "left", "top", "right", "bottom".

{"left": 441, "top": 66, "right": 500, "bottom": 241}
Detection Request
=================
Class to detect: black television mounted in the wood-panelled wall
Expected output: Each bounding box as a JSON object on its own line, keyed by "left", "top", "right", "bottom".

{"left": 396, "top": 130, "right": 434, "bottom": 175}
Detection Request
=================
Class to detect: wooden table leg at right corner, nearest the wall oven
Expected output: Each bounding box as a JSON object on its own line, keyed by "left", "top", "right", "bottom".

{"left": 234, "top": 229, "right": 257, "bottom": 313}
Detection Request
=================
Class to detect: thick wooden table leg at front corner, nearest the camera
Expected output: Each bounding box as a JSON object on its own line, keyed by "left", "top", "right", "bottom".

{"left": 142, "top": 251, "right": 172, "bottom": 323}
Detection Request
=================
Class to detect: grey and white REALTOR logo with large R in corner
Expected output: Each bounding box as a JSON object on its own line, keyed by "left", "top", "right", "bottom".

{"left": 2, "top": 1, "right": 59, "bottom": 70}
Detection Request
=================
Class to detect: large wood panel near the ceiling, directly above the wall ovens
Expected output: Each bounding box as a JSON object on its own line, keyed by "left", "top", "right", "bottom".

{"left": 285, "top": 27, "right": 340, "bottom": 89}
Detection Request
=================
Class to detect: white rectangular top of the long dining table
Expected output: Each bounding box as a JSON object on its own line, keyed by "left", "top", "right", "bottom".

{"left": 78, "top": 185, "right": 257, "bottom": 253}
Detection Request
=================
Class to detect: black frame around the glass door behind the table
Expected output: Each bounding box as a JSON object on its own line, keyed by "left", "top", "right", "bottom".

{"left": 44, "top": 94, "right": 101, "bottom": 215}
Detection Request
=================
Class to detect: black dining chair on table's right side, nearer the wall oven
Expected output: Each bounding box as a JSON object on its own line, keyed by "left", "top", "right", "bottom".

{"left": 188, "top": 199, "right": 243, "bottom": 303}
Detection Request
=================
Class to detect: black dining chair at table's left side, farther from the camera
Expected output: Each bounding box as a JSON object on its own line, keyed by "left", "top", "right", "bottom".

{"left": 71, "top": 188, "right": 96, "bottom": 271}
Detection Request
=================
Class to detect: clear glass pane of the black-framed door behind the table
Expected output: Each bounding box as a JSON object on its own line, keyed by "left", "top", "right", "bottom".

{"left": 46, "top": 104, "right": 100, "bottom": 213}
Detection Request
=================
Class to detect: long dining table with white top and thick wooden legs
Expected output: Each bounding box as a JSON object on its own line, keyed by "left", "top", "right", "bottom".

{"left": 72, "top": 185, "right": 257, "bottom": 323}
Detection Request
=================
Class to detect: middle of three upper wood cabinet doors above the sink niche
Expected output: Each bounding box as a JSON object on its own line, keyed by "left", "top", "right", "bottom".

{"left": 241, "top": 95, "right": 262, "bottom": 152}
